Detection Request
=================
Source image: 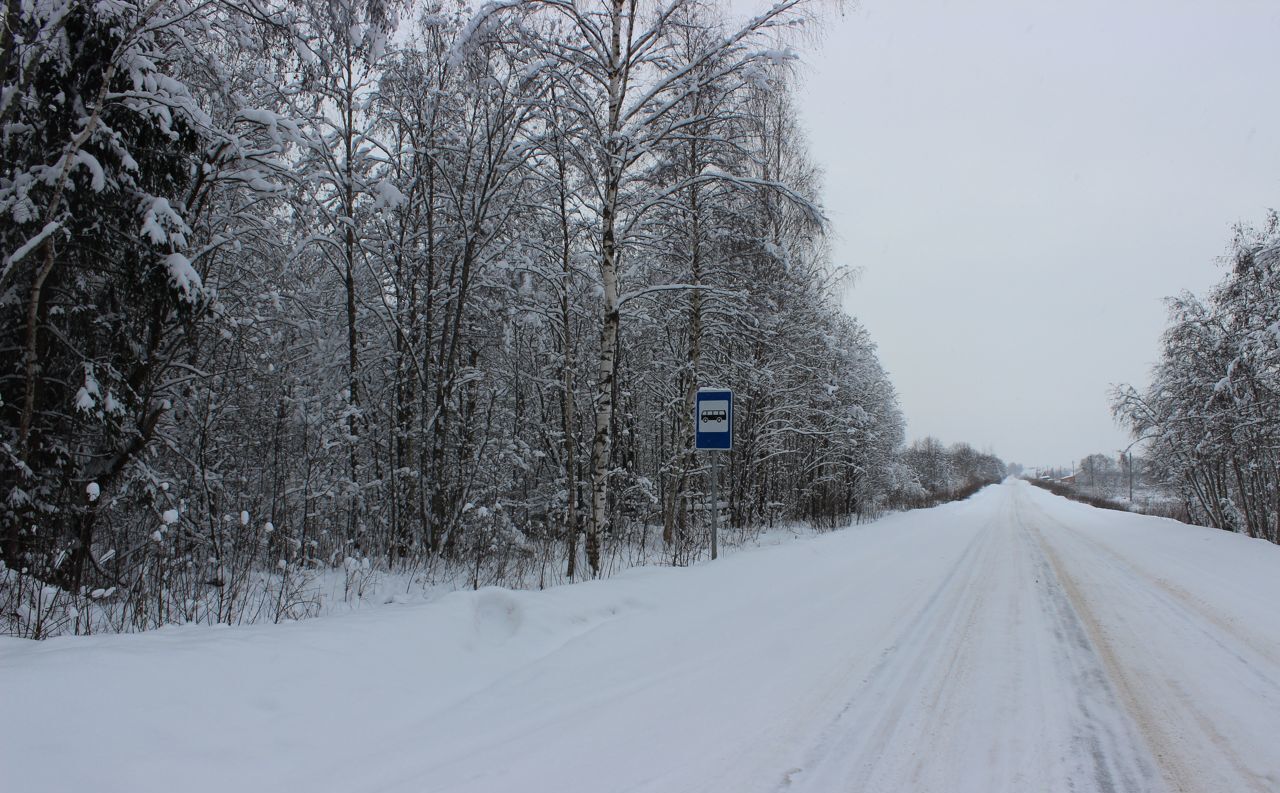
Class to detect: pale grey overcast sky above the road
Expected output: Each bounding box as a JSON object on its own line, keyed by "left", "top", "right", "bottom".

{"left": 800, "top": 0, "right": 1280, "bottom": 466}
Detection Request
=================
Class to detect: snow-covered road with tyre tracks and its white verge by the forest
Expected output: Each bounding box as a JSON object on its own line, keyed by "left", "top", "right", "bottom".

{"left": 0, "top": 482, "right": 1280, "bottom": 793}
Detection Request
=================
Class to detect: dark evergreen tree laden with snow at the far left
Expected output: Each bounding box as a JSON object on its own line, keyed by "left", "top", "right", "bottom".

{"left": 0, "top": 0, "right": 294, "bottom": 598}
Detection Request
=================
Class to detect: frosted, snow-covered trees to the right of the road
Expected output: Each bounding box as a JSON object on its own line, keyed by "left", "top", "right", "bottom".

{"left": 1114, "top": 212, "right": 1280, "bottom": 542}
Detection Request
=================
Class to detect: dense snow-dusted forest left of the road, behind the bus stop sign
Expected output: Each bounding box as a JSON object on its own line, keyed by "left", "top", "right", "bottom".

{"left": 0, "top": 0, "right": 1004, "bottom": 637}
